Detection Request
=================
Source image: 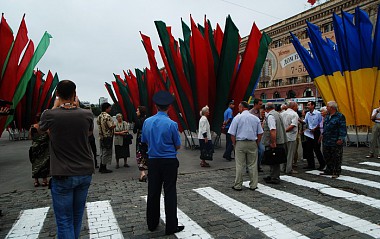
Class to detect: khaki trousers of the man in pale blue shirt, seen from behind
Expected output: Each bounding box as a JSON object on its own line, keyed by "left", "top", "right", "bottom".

{"left": 234, "top": 141, "right": 258, "bottom": 189}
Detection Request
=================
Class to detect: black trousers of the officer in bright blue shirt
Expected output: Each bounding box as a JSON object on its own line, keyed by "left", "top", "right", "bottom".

{"left": 146, "top": 158, "right": 179, "bottom": 232}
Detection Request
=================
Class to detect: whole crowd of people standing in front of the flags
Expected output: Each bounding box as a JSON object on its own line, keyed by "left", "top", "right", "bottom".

{"left": 0, "top": 80, "right": 380, "bottom": 238}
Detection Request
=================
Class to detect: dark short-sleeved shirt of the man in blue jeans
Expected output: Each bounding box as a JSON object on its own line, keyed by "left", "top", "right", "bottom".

{"left": 39, "top": 108, "right": 94, "bottom": 176}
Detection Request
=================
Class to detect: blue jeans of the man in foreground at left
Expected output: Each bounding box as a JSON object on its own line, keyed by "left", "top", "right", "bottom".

{"left": 51, "top": 175, "right": 92, "bottom": 239}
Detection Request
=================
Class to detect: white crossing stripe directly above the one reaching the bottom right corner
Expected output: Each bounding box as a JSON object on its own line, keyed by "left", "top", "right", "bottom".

{"left": 281, "top": 176, "right": 380, "bottom": 209}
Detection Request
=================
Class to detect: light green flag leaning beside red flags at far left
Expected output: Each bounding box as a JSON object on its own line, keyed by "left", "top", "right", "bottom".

{"left": 5, "top": 32, "right": 52, "bottom": 126}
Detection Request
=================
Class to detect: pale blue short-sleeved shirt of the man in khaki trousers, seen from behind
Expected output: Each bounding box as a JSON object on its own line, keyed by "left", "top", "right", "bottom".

{"left": 228, "top": 110, "right": 264, "bottom": 141}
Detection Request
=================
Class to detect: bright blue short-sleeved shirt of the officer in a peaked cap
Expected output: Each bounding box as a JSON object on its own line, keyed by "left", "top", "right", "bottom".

{"left": 141, "top": 111, "right": 181, "bottom": 158}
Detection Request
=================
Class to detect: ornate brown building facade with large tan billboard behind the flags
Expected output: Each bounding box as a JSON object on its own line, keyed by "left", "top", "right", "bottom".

{"left": 240, "top": 0, "right": 380, "bottom": 106}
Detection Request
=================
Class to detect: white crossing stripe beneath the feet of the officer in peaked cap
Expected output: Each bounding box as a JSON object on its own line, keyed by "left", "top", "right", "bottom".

{"left": 142, "top": 195, "right": 213, "bottom": 239}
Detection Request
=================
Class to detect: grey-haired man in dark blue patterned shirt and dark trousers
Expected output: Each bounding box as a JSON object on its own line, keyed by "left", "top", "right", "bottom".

{"left": 321, "top": 101, "right": 347, "bottom": 178}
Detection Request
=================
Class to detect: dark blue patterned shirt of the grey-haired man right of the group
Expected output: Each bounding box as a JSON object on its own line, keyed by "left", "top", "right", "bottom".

{"left": 322, "top": 112, "right": 347, "bottom": 147}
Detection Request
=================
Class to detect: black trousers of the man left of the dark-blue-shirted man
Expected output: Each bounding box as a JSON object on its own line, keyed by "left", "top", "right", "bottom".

{"left": 304, "top": 130, "right": 326, "bottom": 169}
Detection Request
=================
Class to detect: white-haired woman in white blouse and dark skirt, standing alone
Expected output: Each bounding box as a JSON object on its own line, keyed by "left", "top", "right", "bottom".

{"left": 198, "top": 105, "right": 214, "bottom": 167}
